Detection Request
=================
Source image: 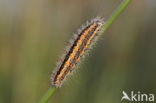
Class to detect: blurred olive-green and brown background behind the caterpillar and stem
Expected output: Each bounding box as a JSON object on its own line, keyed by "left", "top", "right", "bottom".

{"left": 0, "top": 0, "right": 156, "bottom": 103}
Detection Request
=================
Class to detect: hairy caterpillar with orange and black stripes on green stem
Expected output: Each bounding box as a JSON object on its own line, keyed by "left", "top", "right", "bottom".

{"left": 51, "top": 17, "right": 104, "bottom": 87}
